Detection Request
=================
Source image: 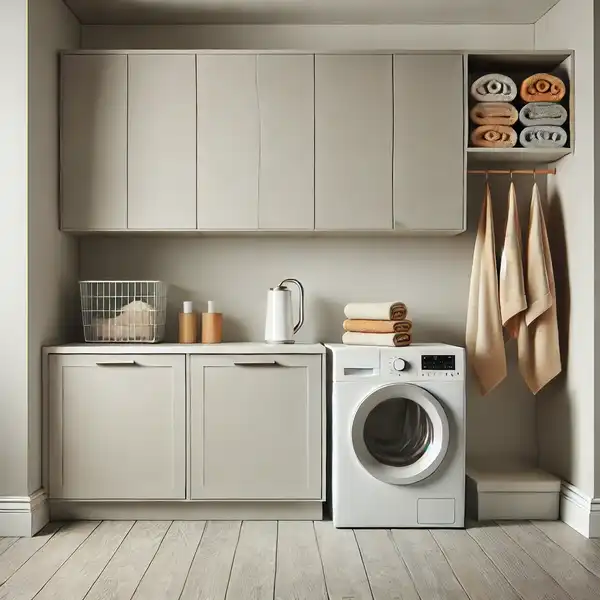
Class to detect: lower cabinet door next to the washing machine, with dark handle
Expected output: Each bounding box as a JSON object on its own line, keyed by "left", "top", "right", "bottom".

{"left": 191, "top": 354, "right": 323, "bottom": 500}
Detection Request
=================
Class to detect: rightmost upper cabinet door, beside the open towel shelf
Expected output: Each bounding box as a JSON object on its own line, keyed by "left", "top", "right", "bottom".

{"left": 394, "top": 54, "right": 465, "bottom": 232}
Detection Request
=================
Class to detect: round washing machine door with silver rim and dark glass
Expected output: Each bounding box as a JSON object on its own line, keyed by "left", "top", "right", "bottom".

{"left": 351, "top": 383, "right": 450, "bottom": 485}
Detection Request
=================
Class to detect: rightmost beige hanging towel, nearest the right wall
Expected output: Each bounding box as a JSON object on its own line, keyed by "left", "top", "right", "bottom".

{"left": 518, "top": 184, "right": 562, "bottom": 394}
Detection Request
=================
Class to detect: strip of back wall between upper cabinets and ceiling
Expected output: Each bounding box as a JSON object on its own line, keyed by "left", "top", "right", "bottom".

{"left": 82, "top": 25, "right": 534, "bottom": 50}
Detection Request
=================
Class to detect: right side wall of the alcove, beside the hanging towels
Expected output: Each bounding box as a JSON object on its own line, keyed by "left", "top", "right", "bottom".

{"left": 535, "top": 0, "right": 600, "bottom": 497}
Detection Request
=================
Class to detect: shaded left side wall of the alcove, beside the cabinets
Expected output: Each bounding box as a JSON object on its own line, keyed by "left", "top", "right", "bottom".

{"left": 27, "top": 0, "right": 80, "bottom": 492}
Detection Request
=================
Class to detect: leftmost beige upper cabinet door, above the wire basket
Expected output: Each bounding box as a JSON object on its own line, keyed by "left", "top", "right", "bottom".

{"left": 61, "top": 54, "right": 127, "bottom": 231}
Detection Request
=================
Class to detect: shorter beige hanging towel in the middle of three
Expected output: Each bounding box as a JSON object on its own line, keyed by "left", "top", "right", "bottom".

{"left": 500, "top": 181, "right": 527, "bottom": 339}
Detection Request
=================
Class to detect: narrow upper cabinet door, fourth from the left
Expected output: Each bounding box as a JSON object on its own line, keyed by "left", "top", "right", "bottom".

{"left": 257, "top": 54, "right": 315, "bottom": 230}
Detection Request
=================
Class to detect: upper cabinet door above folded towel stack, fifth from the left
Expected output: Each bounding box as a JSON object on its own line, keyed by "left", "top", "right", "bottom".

{"left": 315, "top": 55, "right": 394, "bottom": 230}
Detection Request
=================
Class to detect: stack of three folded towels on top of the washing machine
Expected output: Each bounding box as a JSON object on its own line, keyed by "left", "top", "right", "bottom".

{"left": 342, "top": 302, "right": 412, "bottom": 347}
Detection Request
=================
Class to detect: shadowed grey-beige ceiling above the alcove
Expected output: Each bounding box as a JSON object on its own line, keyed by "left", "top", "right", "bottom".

{"left": 64, "top": 0, "right": 559, "bottom": 25}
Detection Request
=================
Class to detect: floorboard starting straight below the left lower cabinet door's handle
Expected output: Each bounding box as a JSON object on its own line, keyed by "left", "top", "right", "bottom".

{"left": 36, "top": 521, "right": 133, "bottom": 600}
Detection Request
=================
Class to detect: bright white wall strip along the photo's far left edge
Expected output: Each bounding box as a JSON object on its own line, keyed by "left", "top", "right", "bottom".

{"left": 0, "top": 0, "right": 27, "bottom": 496}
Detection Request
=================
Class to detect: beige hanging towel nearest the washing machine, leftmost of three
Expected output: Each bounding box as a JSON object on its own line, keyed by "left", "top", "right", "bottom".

{"left": 466, "top": 184, "right": 506, "bottom": 395}
